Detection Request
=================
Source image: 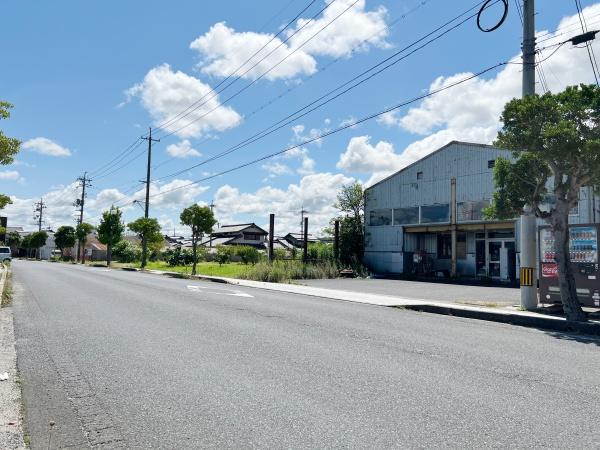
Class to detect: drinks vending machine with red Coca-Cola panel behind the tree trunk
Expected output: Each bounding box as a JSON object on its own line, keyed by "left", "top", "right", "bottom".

{"left": 538, "top": 223, "right": 600, "bottom": 306}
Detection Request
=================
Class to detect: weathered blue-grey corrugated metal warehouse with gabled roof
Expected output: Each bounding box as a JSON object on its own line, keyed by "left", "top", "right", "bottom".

{"left": 364, "top": 141, "right": 599, "bottom": 281}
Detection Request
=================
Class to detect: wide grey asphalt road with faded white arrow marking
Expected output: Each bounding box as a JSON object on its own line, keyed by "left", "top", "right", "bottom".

{"left": 13, "top": 261, "right": 600, "bottom": 449}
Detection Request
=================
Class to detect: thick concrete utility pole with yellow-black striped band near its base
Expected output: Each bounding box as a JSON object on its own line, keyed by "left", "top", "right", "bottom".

{"left": 520, "top": 0, "right": 538, "bottom": 311}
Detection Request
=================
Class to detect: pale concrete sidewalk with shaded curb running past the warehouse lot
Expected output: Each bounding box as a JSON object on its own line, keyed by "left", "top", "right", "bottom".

{"left": 136, "top": 270, "right": 600, "bottom": 336}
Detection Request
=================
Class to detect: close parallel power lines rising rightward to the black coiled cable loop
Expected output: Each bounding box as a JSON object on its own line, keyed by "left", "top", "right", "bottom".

{"left": 152, "top": 0, "right": 500, "bottom": 180}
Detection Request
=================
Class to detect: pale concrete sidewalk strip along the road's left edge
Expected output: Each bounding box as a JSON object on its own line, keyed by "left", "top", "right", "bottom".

{"left": 0, "top": 267, "right": 26, "bottom": 449}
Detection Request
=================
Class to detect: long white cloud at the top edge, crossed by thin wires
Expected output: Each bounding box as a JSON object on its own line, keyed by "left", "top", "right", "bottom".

{"left": 190, "top": 0, "right": 388, "bottom": 80}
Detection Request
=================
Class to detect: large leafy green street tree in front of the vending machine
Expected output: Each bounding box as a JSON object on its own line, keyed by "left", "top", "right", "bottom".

{"left": 486, "top": 85, "right": 600, "bottom": 321}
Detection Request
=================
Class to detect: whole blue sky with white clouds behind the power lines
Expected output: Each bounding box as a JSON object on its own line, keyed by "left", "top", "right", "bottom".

{"left": 0, "top": 0, "right": 600, "bottom": 234}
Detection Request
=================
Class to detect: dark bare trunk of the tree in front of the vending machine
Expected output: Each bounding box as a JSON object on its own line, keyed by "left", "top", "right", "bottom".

{"left": 551, "top": 210, "right": 587, "bottom": 322}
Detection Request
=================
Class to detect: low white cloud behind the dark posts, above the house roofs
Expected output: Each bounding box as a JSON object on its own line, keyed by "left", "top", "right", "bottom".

{"left": 215, "top": 173, "right": 354, "bottom": 236}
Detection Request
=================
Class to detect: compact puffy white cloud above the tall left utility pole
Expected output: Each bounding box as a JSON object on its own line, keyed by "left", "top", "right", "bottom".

{"left": 126, "top": 64, "right": 242, "bottom": 138}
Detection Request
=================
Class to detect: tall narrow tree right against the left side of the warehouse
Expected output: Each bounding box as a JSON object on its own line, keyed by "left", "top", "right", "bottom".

{"left": 332, "top": 182, "right": 365, "bottom": 267}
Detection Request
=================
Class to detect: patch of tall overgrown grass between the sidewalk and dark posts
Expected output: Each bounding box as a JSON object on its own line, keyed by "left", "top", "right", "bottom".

{"left": 240, "top": 260, "right": 339, "bottom": 283}
